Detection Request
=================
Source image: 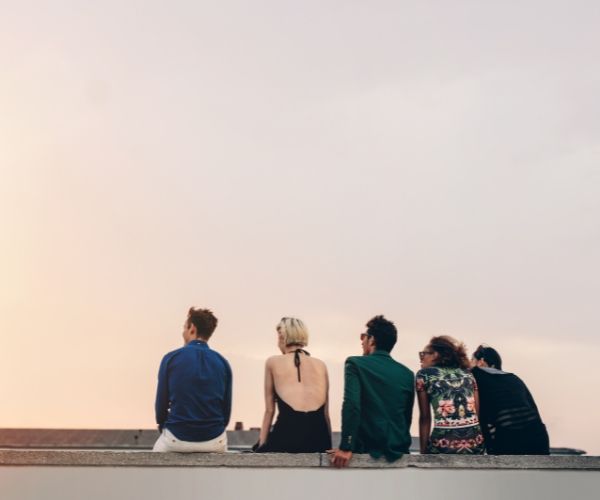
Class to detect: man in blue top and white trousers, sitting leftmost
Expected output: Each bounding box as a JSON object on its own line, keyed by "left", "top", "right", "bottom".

{"left": 153, "top": 307, "right": 231, "bottom": 452}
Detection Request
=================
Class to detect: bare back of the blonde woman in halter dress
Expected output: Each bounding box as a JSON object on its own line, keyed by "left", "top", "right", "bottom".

{"left": 267, "top": 353, "right": 329, "bottom": 411}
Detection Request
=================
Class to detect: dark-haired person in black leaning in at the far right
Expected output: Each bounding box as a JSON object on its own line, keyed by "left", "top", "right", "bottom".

{"left": 472, "top": 345, "right": 550, "bottom": 455}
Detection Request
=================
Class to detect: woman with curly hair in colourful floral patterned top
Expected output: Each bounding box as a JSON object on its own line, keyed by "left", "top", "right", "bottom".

{"left": 416, "top": 335, "right": 484, "bottom": 455}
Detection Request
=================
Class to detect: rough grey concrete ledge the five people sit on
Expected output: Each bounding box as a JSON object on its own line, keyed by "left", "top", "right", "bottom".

{"left": 0, "top": 450, "right": 600, "bottom": 471}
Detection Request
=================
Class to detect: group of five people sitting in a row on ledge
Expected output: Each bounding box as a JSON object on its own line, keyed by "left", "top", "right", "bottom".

{"left": 154, "top": 308, "right": 549, "bottom": 467}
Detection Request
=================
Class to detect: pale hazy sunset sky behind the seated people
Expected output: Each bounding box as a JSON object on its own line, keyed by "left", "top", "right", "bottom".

{"left": 0, "top": 0, "right": 600, "bottom": 454}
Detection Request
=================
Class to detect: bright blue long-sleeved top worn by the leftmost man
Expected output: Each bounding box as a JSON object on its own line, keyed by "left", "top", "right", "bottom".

{"left": 155, "top": 340, "right": 232, "bottom": 442}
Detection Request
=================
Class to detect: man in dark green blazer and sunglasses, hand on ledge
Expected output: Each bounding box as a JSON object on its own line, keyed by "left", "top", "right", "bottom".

{"left": 329, "top": 316, "right": 415, "bottom": 467}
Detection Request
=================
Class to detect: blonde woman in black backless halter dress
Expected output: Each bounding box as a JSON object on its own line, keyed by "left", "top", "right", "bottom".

{"left": 256, "top": 318, "right": 331, "bottom": 453}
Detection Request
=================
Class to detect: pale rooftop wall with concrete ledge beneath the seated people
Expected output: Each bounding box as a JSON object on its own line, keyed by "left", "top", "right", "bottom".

{"left": 0, "top": 450, "right": 600, "bottom": 500}
